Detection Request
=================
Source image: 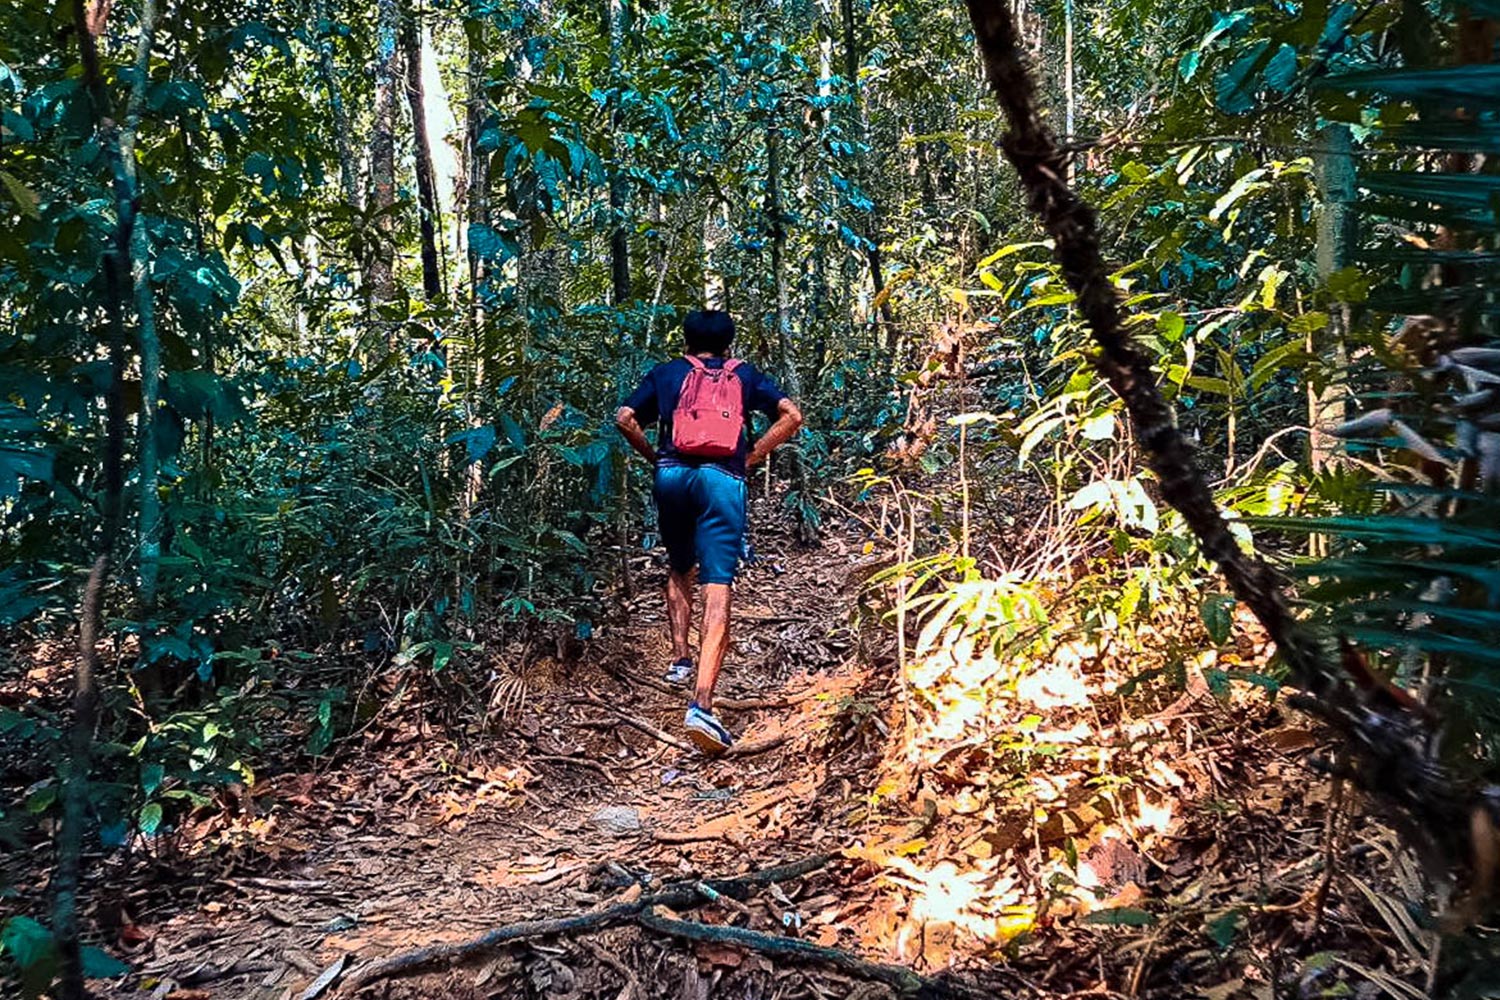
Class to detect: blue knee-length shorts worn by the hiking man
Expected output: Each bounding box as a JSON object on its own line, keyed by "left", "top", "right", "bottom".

{"left": 654, "top": 465, "right": 746, "bottom": 583}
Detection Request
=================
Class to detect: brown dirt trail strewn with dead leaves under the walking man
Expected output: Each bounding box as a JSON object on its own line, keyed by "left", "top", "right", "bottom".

{"left": 105, "top": 515, "right": 900, "bottom": 1000}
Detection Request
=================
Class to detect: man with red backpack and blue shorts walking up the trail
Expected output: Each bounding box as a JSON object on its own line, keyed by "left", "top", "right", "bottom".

{"left": 615, "top": 310, "right": 803, "bottom": 754}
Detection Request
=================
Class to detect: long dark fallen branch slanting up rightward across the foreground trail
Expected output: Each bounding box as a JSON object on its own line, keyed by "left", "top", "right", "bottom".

{"left": 339, "top": 855, "right": 833, "bottom": 994}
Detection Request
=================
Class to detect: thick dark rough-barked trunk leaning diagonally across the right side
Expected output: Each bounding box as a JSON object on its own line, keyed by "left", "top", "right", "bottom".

{"left": 966, "top": 0, "right": 1496, "bottom": 891}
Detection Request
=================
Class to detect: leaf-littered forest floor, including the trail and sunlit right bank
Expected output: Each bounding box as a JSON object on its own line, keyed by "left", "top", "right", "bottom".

{"left": 2, "top": 501, "right": 1428, "bottom": 1000}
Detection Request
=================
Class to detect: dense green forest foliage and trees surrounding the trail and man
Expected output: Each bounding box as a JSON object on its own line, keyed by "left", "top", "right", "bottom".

{"left": 0, "top": 0, "right": 1500, "bottom": 995}
